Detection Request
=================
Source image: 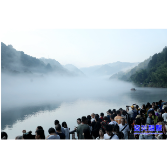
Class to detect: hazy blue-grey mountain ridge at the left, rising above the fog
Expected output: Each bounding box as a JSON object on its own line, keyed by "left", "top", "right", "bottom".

{"left": 1, "top": 42, "right": 74, "bottom": 76}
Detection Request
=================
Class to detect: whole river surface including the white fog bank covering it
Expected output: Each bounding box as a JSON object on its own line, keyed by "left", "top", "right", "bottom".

{"left": 1, "top": 73, "right": 167, "bottom": 140}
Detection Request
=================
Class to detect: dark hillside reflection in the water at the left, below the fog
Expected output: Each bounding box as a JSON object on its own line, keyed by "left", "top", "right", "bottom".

{"left": 1, "top": 102, "right": 61, "bottom": 130}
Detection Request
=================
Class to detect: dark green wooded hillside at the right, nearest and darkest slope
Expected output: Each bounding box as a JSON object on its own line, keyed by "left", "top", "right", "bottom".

{"left": 130, "top": 46, "right": 167, "bottom": 87}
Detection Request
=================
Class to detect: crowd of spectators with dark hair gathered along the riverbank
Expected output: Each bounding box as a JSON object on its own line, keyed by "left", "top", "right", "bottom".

{"left": 1, "top": 100, "right": 167, "bottom": 140}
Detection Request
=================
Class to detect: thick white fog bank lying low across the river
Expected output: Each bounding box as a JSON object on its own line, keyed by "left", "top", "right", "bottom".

{"left": 1, "top": 73, "right": 136, "bottom": 112}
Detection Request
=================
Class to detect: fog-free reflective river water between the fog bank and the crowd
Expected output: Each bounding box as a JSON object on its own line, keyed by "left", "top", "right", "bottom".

{"left": 1, "top": 82, "right": 167, "bottom": 140}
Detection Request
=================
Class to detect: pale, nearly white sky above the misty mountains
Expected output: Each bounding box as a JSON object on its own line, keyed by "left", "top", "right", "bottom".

{"left": 1, "top": 28, "right": 167, "bottom": 68}
